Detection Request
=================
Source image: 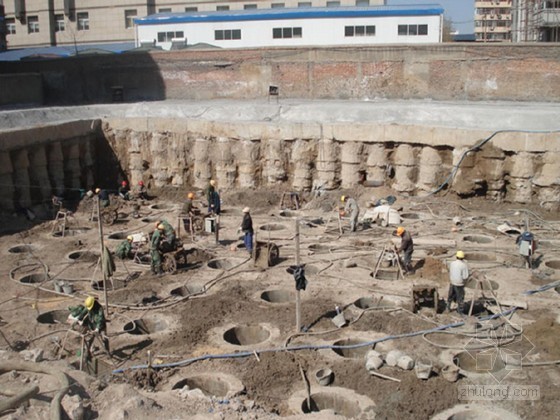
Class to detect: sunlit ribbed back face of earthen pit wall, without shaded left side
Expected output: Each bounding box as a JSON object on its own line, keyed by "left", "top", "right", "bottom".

{"left": 103, "top": 118, "right": 560, "bottom": 207}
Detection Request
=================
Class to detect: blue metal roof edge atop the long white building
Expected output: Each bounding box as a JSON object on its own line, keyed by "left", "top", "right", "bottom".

{"left": 134, "top": 4, "right": 444, "bottom": 25}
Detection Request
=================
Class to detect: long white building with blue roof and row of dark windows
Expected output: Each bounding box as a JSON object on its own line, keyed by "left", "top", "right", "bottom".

{"left": 135, "top": 5, "right": 444, "bottom": 50}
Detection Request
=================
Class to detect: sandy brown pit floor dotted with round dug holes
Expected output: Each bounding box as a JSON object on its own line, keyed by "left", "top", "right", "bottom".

{"left": 0, "top": 188, "right": 560, "bottom": 419}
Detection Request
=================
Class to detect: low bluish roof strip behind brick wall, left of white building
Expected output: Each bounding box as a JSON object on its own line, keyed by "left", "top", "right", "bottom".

{"left": 0, "top": 42, "right": 135, "bottom": 61}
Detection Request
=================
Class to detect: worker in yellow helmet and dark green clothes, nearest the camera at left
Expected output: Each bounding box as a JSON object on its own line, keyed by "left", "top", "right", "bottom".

{"left": 68, "top": 296, "right": 109, "bottom": 354}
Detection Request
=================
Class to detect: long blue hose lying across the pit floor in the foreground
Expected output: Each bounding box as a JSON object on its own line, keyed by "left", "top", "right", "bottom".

{"left": 112, "top": 308, "right": 517, "bottom": 374}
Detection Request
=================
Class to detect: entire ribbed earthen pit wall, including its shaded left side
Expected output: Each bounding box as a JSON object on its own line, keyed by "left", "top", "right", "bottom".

{"left": 0, "top": 118, "right": 560, "bottom": 210}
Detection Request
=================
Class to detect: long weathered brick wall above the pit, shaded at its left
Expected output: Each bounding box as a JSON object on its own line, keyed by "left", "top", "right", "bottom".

{"left": 0, "top": 43, "right": 560, "bottom": 104}
